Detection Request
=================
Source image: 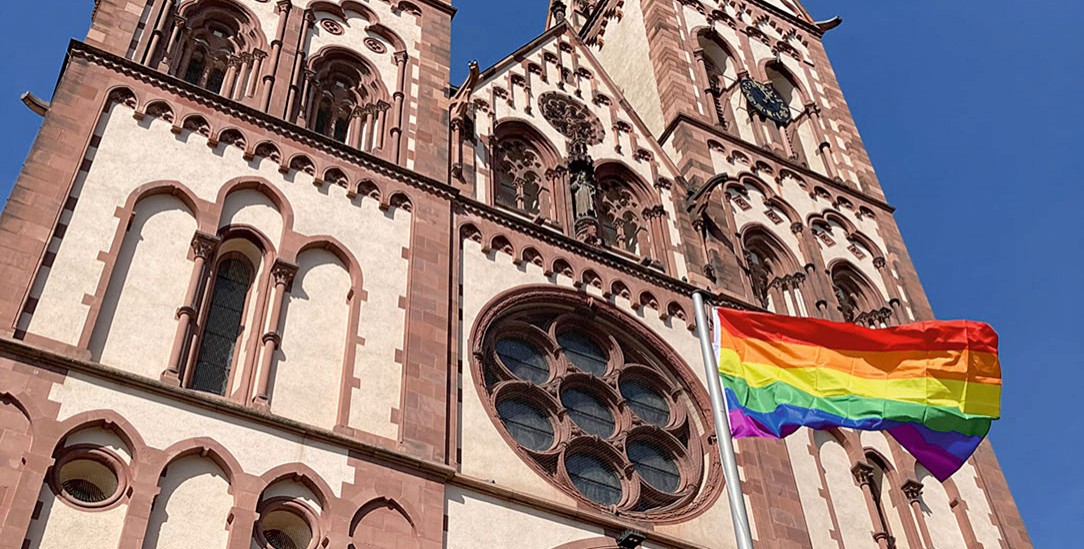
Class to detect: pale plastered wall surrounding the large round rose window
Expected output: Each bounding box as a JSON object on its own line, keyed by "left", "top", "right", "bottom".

{"left": 457, "top": 240, "right": 754, "bottom": 547}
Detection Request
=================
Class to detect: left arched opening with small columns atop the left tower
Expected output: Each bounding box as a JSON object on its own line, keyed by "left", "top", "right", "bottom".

{"left": 167, "top": 0, "right": 263, "bottom": 99}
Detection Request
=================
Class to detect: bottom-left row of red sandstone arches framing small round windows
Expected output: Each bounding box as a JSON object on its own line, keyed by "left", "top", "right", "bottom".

{"left": 0, "top": 407, "right": 424, "bottom": 549}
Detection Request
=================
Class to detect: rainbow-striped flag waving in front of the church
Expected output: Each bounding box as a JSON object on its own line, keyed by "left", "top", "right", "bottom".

{"left": 715, "top": 308, "right": 1002, "bottom": 481}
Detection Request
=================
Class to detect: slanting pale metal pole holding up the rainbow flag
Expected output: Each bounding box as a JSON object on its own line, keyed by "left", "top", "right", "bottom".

{"left": 693, "top": 291, "right": 753, "bottom": 549}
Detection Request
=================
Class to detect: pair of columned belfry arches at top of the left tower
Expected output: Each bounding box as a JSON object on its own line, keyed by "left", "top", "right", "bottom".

{"left": 134, "top": 0, "right": 409, "bottom": 161}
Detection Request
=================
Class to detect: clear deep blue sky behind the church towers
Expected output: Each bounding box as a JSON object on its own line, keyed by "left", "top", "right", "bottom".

{"left": 0, "top": 0, "right": 1084, "bottom": 547}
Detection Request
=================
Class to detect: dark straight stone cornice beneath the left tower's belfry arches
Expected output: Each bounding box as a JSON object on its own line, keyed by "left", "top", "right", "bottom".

{"left": 62, "top": 40, "right": 459, "bottom": 199}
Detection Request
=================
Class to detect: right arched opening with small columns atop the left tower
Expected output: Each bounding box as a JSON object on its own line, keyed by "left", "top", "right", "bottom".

{"left": 302, "top": 48, "right": 391, "bottom": 152}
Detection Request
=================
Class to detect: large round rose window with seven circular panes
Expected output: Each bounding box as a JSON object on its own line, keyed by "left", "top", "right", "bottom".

{"left": 474, "top": 291, "right": 721, "bottom": 521}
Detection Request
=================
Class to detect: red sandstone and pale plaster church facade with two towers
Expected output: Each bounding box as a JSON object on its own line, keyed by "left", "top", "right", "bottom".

{"left": 0, "top": 0, "right": 1031, "bottom": 549}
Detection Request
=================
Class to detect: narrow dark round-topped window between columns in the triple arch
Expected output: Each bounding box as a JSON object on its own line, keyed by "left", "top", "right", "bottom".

{"left": 190, "top": 255, "right": 255, "bottom": 395}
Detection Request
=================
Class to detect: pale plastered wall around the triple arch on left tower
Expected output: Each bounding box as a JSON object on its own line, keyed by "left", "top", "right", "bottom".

{"left": 28, "top": 105, "right": 412, "bottom": 438}
